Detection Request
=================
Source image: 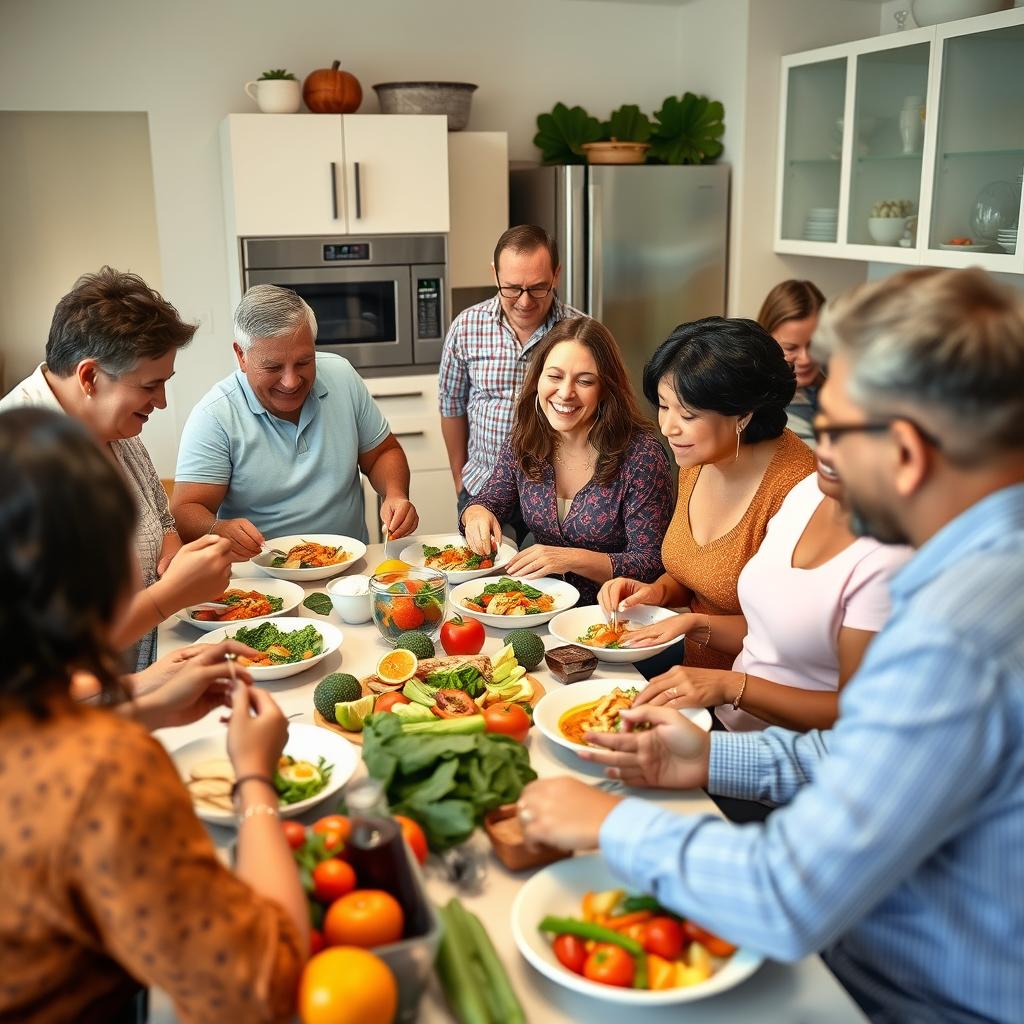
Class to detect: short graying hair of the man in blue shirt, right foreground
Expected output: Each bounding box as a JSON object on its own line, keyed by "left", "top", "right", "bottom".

{"left": 815, "top": 268, "right": 1024, "bottom": 465}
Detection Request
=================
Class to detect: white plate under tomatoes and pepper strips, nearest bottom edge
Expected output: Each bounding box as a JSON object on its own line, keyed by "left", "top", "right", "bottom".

{"left": 512, "top": 856, "right": 764, "bottom": 1007}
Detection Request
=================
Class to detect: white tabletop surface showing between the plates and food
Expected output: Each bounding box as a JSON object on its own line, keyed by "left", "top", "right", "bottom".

{"left": 150, "top": 540, "right": 865, "bottom": 1024}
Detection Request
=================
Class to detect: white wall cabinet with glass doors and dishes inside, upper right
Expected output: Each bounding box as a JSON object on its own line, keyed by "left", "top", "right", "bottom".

{"left": 774, "top": 8, "right": 1024, "bottom": 273}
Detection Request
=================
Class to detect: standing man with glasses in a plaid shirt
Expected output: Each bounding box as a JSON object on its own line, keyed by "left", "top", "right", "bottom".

{"left": 437, "top": 224, "right": 581, "bottom": 542}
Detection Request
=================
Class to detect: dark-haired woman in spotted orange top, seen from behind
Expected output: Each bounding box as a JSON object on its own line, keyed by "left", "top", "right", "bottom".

{"left": 0, "top": 409, "right": 308, "bottom": 1024}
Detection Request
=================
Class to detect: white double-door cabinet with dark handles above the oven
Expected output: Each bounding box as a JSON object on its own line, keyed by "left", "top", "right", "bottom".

{"left": 221, "top": 114, "right": 449, "bottom": 238}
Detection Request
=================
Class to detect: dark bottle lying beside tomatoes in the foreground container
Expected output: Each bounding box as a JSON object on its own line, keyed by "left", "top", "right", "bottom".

{"left": 345, "top": 778, "right": 430, "bottom": 939}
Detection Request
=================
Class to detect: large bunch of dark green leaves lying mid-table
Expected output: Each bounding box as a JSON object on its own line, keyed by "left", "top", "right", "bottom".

{"left": 362, "top": 714, "right": 537, "bottom": 850}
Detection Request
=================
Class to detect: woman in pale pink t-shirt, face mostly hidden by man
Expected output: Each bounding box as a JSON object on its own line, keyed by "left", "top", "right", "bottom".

{"left": 637, "top": 454, "right": 911, "bottom": 731}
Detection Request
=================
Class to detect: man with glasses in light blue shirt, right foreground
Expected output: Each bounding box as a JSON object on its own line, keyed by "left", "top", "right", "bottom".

{"left": 520, "top": 269, "right": 1024, "bottom": 1024}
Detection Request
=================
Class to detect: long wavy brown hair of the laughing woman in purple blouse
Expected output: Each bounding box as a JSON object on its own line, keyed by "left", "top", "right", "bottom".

{"left": 510, "top": 316, "right": 657, "bottom": 485}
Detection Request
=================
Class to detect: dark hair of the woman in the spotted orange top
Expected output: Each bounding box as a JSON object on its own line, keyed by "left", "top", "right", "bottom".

{"left": 0, "top": 408, "right": 135, "bottom": 718}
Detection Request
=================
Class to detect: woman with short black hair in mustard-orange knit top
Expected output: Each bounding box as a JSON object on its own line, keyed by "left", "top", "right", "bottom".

{"left": 599, "top": 316, "right": 814, "bottom": 669}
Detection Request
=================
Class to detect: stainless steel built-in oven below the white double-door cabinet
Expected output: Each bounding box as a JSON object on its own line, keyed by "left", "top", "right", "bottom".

{"left": 242, "top": 234, "right": 447, "bottom": 373}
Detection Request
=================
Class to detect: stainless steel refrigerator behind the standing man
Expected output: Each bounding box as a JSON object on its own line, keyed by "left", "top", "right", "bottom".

{"left": 509, "top": 165, "right": 729, "bottom": 397}
